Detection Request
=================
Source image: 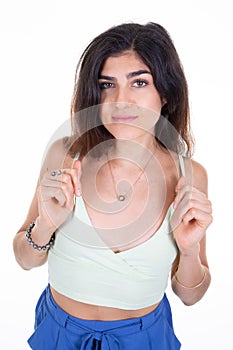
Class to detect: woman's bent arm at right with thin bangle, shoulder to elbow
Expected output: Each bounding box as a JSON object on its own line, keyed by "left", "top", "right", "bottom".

{"left": 171, "top": 161, "right": 212, "bottom": 305}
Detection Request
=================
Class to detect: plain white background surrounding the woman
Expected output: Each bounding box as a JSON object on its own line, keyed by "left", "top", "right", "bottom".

{"left": 0, "top": 0, "right": 233, "bottom": 350}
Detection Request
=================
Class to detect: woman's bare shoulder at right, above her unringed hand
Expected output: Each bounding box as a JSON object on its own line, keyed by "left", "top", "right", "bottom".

{"left": 184, "top": 158, "right": 208, "bottom": 194}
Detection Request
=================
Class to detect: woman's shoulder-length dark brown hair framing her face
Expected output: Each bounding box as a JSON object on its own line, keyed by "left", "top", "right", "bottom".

{"left": 70, "top": 22, "right": 193, "bottom": 157}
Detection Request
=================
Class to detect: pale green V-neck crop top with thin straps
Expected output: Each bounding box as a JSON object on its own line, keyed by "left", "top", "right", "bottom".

{"left": 48, "top": 157, "right": 184, "bottom": 310}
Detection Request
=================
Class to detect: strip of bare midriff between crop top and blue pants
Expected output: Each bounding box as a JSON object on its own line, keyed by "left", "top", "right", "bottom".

{"left": 50, "top": 286, "right": 159, "bottom": 321}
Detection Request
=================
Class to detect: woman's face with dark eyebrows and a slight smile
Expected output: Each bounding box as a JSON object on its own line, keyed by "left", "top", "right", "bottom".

{"left": 99, "top": 51, "right": 163, "bottom": 139}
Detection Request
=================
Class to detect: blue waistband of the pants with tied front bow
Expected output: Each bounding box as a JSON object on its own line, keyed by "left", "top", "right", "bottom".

{"left": 46, "top": 286, "right": 169, "bottom": 340}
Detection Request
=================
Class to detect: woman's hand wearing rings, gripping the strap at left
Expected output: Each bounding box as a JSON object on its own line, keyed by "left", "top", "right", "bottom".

{"left": 37, "top": 160, "right": 81, "bottom": 232}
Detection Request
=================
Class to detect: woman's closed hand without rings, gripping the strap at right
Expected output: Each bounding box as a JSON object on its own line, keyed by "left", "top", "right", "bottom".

{"left": 171, "top": 176, "right": 212, "bottom": 254}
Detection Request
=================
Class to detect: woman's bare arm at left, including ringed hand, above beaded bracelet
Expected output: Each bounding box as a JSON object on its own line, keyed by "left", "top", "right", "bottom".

{"left": 13, "top": 140, "right": 81, "bottom": 270}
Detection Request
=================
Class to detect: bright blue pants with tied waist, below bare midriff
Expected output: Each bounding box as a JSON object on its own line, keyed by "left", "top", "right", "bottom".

{"left": 28, "top": 286, "right": 180, "bottom": 350}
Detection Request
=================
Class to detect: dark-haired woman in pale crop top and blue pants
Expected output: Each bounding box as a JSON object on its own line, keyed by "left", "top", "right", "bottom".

{"left": 14, "top": 23, "right": 212, "bottom": 350}
